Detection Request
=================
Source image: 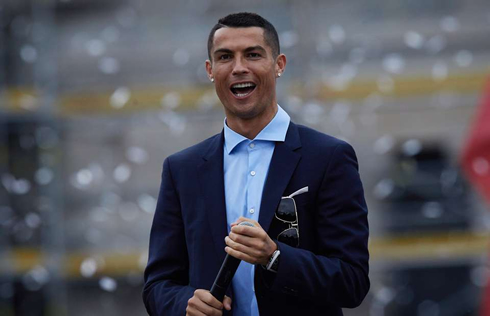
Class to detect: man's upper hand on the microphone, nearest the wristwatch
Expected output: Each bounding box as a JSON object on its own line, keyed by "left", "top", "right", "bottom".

{"left": 225, "top": 217, "right": 277, "bottom": 266}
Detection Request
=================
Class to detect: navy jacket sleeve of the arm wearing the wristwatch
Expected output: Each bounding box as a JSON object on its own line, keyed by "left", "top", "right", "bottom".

{"left": 256, "top": 142, "right": 370, "bottom": 308}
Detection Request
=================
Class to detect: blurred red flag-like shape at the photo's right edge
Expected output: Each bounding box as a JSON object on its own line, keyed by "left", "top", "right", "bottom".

{"left": 462, "top": 80, "right": 490, "bottom": 316}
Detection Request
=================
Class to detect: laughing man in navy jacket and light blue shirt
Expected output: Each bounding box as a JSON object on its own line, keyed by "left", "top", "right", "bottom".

{"left": 143, "top": 13, "right": 369, "bottom": 316}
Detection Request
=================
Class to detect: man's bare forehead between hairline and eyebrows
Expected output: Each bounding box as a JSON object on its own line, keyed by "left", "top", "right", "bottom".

{"left": 213, "top": 26, "right": 269, "bottom": 50}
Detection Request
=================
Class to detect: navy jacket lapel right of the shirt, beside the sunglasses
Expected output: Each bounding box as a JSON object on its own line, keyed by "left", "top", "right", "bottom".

{"left": 259, "top": 122, "right": 301, "bottom": 231}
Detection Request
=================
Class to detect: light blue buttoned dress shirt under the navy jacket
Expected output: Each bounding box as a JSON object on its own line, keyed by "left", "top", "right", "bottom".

{"left": 223, "top": 105, "right": 290, "bottom": 316}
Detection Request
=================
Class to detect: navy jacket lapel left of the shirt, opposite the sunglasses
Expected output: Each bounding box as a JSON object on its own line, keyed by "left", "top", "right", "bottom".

{"left": 198, "top": 132, "right": 227, "bottom": 259}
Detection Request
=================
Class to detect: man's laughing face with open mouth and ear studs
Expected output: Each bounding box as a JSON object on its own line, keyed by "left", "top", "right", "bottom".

{"left": 206, "top": 27, "right": 286, "bottom": 120}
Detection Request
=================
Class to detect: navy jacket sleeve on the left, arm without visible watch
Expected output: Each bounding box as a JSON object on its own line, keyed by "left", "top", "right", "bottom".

{"left": 143, "top": 158, "right": 195, "bottom": 315}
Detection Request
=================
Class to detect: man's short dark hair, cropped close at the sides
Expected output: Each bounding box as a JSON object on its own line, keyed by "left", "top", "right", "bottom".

{"left": 208, "top": 12, "right": 281, "bottom": 60}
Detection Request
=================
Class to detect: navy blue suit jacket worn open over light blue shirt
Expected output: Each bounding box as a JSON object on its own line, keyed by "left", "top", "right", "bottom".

{"left": 143, "top": 122, "right": 369, "bottom": 316}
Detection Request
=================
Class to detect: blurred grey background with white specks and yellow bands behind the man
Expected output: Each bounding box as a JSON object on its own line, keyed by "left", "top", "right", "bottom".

{"left": 0, "top": 0, "right": 490, "bottom": 316}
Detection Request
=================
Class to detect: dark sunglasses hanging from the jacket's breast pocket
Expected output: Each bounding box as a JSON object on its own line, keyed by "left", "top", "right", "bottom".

{"left": 276, "top": 196, "right": 299, "bottom": 247}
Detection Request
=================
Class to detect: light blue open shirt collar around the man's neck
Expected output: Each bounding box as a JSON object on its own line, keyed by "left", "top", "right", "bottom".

{"left": 224, "top": 104, "right": 291, "bottom": 154}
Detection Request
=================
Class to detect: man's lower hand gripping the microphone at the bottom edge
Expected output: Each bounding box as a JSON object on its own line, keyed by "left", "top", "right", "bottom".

{"left": 186, "top": 290, "right": 231, "bottom": 316}
